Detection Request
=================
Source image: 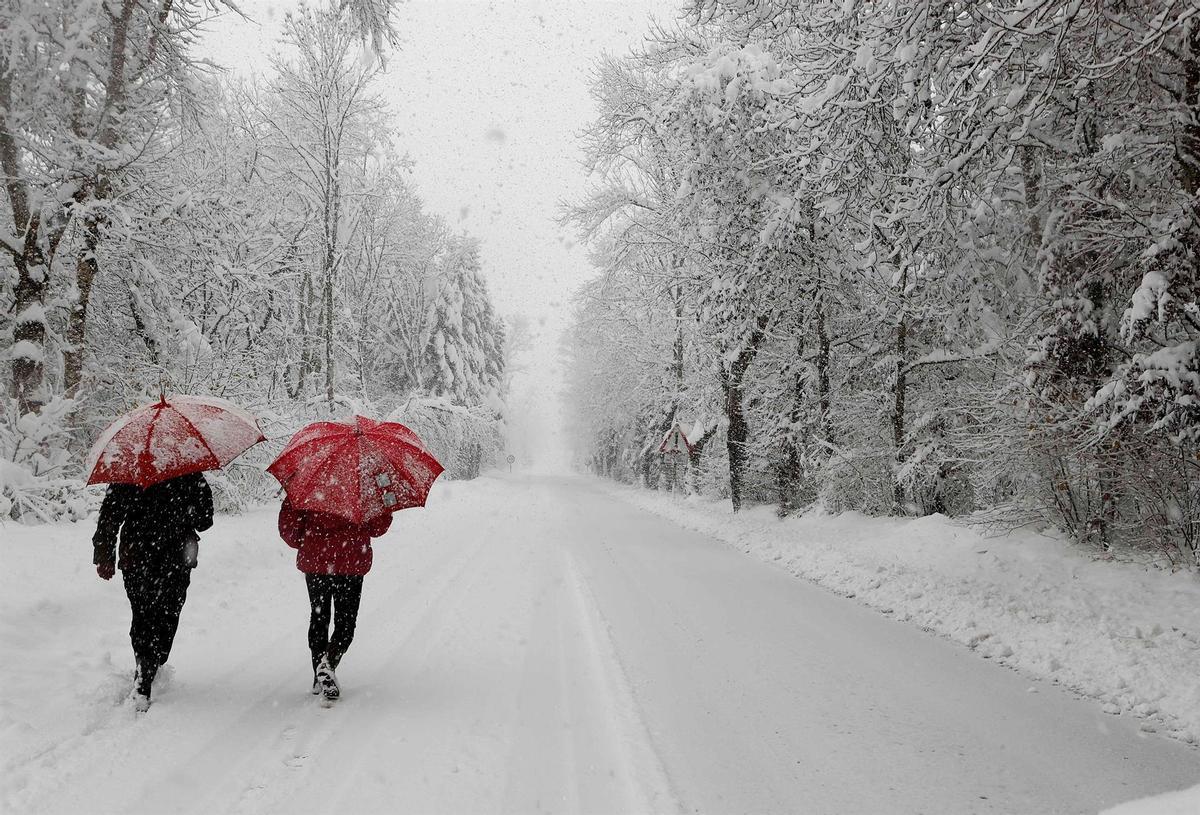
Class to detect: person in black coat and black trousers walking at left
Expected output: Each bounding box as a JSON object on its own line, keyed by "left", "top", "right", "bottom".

{"left": 92, "top": 473, "right": 212, "bottom": 711}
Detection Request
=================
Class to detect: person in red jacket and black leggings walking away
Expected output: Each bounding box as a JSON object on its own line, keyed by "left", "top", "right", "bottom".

{"left": 280, "top": 499, "right": 391, "bottom": 700}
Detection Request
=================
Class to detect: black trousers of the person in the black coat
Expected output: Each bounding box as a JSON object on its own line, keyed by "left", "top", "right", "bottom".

{"left": 121, "top": 567, "right": 192, "bottom": 688}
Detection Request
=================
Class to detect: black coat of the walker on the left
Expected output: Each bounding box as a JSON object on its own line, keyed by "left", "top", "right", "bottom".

{"left": 91, "top": 473, "right": 212, "bottom": 570}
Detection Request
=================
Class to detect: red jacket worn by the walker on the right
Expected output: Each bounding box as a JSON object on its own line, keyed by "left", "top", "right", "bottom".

{"left": 280, "top": 502, "right": 391, "bottom": 575}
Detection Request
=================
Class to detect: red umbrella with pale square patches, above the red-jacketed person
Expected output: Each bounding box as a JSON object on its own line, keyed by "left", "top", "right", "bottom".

{"left": 266, "top": 417, "right": 442, "bottom": 523}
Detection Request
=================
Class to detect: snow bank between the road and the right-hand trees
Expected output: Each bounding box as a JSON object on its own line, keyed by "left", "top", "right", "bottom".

{"left": 612, "top": 486, "right": 1200, "bottom": 744}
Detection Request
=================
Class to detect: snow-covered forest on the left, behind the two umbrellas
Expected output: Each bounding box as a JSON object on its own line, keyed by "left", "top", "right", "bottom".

{"left": 0, "top": 0, "right": 509, "bottom": 522}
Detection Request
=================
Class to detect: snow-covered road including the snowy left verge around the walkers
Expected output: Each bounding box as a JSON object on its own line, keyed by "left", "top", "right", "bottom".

{"left": 0, "top": 478, "right": 1200, "bottom": 815}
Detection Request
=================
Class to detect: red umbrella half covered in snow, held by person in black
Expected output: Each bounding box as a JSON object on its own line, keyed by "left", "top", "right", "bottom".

{"left": 85, "top": 396, "right": 266, "bottom": 487}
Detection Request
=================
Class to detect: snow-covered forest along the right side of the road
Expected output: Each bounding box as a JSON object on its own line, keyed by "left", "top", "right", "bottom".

{"left": 565, "top": 0, "right": 1200, "bottom": 569}
